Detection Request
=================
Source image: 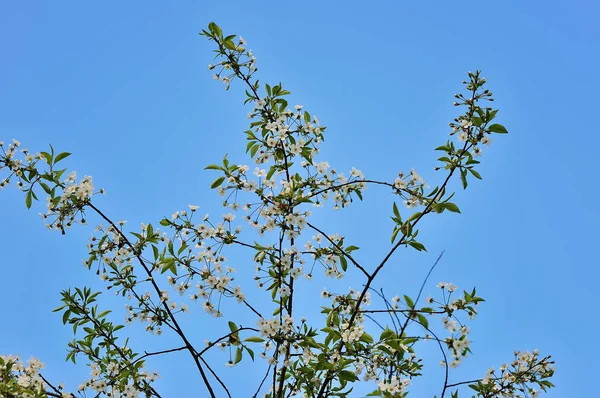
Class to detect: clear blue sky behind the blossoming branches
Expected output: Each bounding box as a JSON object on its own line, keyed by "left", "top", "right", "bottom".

{"left": 0, "top": 1, "right": 600, "bottom": 397}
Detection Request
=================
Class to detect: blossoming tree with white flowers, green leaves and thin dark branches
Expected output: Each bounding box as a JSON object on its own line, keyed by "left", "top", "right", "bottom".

{"left": 0, "top": 23, "right": 554, "bottom": 398}
